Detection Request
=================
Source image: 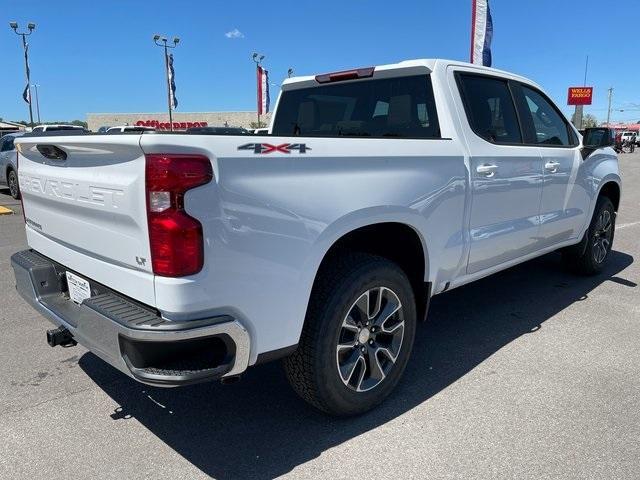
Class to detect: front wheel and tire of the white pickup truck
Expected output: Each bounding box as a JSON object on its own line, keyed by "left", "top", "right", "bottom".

{"left": 562, "top": 196, "right": 616, "bottom": 275}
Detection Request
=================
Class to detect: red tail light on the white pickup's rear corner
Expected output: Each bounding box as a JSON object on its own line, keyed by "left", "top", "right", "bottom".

{"left": 145, "top": 154, "right": 213, "bottom": 277}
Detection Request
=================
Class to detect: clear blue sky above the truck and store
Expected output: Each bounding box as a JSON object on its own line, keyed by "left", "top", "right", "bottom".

{"left": 0, "top": 0, "right": 640, "bottom": 122}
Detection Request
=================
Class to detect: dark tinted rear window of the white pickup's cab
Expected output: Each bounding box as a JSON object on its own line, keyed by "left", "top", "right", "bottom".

{"left": 272, "top": 75, "right": 440, "bottom": 138}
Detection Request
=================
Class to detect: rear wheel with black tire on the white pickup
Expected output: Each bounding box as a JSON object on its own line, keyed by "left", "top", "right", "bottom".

{"left": 284, "top": 252, "right": 416, "bottom": 416}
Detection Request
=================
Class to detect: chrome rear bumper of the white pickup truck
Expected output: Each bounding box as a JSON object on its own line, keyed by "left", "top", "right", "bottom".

{"left": 11, "top": 250, "right": 250, "bottom": 386}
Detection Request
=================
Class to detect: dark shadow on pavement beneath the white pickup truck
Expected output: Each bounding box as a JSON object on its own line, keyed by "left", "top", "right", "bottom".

{"left": 80, "top": 251, "right": 637, "bottom": 479}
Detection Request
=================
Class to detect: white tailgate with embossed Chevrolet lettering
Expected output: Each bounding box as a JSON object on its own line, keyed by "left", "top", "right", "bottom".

{"left": 16, "top": 135, "right": 154, "bottom": 303}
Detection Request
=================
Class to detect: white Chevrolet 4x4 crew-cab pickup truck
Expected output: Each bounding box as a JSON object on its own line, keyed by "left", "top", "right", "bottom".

{"left": 12, "top": 60, "right": 621, "bottom": 415}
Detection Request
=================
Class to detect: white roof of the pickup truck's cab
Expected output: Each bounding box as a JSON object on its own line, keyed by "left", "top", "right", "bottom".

{"left": 282, "top": 58, "right": 539, "bottom": 90}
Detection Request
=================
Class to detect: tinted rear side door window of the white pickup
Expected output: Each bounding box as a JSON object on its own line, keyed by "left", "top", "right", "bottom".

{"left": 458, "top": 73, "right": 522, "bottom": 144}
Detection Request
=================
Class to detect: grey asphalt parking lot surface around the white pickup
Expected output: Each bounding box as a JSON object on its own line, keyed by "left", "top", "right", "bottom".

{"left": 0, "top": 153, "right": 640, "bottom": 479}
